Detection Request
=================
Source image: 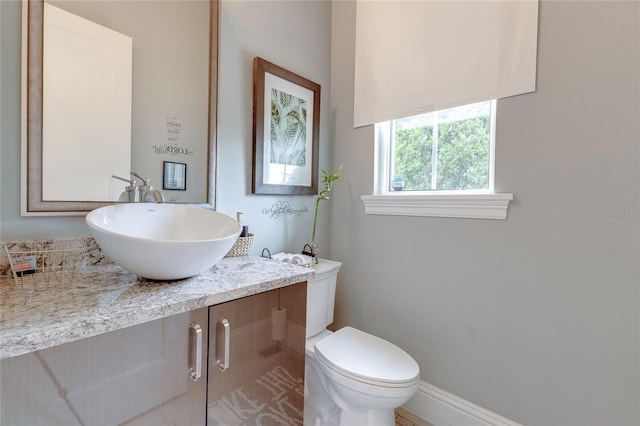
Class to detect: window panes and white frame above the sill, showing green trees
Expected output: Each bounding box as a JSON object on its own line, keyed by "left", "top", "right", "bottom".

{"left": 378, "top": 101, "right": 495, "bottom": 192}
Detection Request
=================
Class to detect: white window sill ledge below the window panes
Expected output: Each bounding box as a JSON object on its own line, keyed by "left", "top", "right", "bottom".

{"left": 360, "top": 193, "right": 513, "bottom": 220}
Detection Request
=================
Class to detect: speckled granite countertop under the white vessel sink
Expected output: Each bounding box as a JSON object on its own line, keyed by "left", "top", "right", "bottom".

{"left": 0, "top": 238, "right": 314, "bottom": 359}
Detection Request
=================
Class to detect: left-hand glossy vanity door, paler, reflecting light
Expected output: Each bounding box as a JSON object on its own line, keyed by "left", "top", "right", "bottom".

{"left": 0, "top": 308, "right": 207, "bottom": 426}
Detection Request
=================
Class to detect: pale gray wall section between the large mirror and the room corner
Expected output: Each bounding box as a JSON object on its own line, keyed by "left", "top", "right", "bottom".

{"left": 217, "top": 0, "right": 333, "bottom": 254}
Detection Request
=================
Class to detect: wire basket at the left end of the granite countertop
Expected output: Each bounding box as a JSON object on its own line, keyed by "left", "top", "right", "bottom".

{"left": 4, "top": 239, "right": 88, "bottom": 288}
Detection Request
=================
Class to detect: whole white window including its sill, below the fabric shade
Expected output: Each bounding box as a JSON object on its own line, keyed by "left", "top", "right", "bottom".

{"left": 362, "top": 100, "right": 513, "bottom": 219}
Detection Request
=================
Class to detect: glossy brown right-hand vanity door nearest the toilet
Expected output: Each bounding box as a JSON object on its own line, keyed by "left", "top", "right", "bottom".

{"left": 207, "top": 283, "right": 307, "bottom": 426}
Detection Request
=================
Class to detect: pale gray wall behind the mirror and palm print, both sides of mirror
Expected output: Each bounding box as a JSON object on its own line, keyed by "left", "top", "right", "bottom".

{"left": 0, "top": 0, "right": 333, "bottom": 254}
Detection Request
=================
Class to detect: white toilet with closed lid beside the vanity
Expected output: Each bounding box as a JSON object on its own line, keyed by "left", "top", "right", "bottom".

{"left": 304, "top": 259, "right": 420, "bottom": 426}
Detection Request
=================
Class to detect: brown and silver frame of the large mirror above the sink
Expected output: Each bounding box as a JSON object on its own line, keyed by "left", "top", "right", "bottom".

{"left": 20, "top": 0, "right": 220, "bottom": 216}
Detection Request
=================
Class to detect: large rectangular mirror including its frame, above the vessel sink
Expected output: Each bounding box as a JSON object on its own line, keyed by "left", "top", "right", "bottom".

{"left": 22, "top": 0, "right": 219, "bottom": 216}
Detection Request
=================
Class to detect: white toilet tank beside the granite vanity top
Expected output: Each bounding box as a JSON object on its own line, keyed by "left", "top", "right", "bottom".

{"left": 307, "top": 259, "right": 342, "bottom": 339}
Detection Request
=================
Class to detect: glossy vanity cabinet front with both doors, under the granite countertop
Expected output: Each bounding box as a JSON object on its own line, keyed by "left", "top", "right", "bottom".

{"left": 0, "top": 282, "right": 306, "bottom": 426}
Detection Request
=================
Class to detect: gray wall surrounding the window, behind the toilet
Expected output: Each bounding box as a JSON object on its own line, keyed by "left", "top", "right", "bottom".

{"left": 331, "top": 1, "right": 640, "bottom": 425}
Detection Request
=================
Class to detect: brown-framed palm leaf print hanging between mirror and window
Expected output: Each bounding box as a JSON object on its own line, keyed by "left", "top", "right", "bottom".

{"left": 252, "top": 57, "right": 320, "bottom": 195}
